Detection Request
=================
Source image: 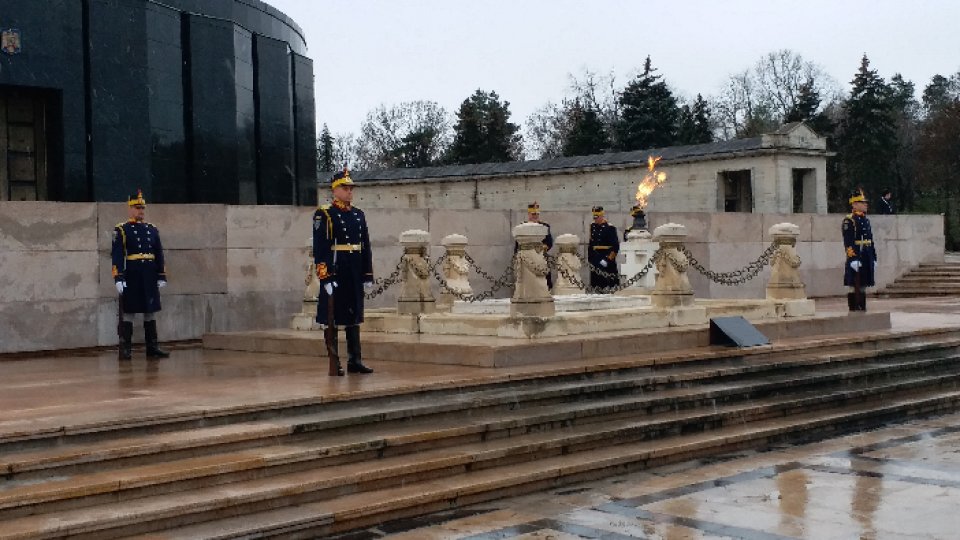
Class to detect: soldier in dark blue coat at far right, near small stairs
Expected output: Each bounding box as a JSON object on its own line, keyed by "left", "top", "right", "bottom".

{"left": 842, "top": 189, "right": 877, "bottom": 311}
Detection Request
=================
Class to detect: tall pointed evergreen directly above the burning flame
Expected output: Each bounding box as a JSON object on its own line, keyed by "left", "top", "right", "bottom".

{"left": 616, "top": 56, "right": 680, "bottom": 150}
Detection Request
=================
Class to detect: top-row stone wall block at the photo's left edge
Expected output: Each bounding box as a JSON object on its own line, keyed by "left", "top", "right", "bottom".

{"left": 0, "top": 201, "right": 98, "bottom": 252}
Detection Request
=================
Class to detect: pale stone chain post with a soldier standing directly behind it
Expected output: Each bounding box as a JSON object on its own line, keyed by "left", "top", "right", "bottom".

{"left": 510, "top": 223, "right": 556, "bottom": 317}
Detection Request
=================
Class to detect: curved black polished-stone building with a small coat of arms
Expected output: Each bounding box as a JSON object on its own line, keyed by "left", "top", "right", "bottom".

{"left": 0, "top": 0, "right": 317, "bottom": 205}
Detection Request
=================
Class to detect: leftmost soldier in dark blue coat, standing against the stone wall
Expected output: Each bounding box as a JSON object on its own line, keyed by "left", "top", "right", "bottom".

{"left": 111, "top": 190, "right": 170, "bottom": 360}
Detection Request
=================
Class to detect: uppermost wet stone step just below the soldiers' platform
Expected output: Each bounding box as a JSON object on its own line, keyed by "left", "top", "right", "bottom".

{"left": 0, "top": 338, "right": 960, "bottom": 489}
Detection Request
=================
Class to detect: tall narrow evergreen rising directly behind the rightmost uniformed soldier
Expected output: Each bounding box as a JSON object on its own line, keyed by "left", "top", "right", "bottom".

{"left": 837, "top": 55, "right": 897, "bottom": 196}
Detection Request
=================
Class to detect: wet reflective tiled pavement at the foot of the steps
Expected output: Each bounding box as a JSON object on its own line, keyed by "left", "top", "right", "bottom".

{"left": 338, "top": 414, "right": 960, "bottom": 540}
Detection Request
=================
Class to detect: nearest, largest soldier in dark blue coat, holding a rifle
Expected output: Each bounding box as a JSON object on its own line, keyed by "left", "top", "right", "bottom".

{"left": 313, "top": 167, "right": 373, "bottom": 375}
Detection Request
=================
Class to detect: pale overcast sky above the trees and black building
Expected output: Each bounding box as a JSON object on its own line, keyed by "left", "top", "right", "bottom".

{"left": 266, "top": 0, "right": 960, "bottom": 138}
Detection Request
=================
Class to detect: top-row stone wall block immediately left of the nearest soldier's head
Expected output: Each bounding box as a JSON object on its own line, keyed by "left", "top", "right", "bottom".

{"left": 226, "top": 206, "right": 315, "bottom": 248}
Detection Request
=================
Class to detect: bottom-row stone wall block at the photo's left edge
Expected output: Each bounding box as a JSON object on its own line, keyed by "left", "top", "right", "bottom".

{"left": 0, "top": 298, "right": 99, "bottom": 353}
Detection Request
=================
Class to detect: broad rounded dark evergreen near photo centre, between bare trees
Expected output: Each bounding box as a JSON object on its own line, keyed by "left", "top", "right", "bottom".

{"left": 446, "top": 89, "right": 521, "bottom": 165}
